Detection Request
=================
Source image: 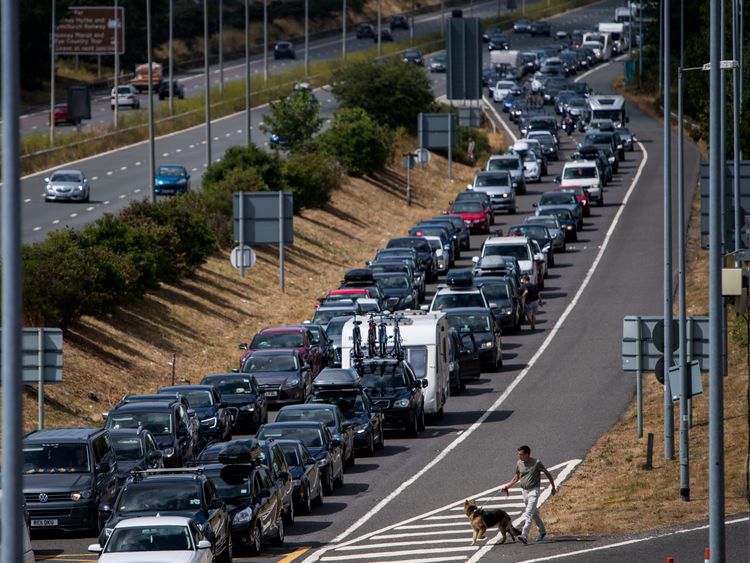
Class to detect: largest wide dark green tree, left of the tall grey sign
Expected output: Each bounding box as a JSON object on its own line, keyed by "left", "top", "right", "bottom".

{"left": 332, "top": 60, "right": 433, "bottom": 131}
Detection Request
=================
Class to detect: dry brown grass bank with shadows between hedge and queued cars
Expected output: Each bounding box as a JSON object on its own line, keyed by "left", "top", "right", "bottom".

{"left": 10, "top": 137, "right": 473, "bottom": 429}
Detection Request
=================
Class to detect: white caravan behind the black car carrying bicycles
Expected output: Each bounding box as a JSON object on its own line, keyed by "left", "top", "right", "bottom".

{"left": 341, "top": 310, "right": 450, "bottom": 417}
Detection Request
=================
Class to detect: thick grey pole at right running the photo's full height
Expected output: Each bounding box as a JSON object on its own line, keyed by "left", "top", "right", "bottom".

{"left": 708, "top": 0, "right": 726, "bottom": 562}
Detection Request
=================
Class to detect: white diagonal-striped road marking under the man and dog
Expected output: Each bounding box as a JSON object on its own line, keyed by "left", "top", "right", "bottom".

{"left": 305, "top": 459, "right": 581, "bottom": 562}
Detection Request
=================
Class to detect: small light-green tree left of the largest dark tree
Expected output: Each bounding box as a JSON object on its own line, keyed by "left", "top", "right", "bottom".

{"left": 260, "top": 89, "right": 323, "bottom": 152}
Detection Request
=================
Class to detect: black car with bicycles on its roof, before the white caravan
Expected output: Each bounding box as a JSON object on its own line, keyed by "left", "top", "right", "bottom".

{"left": 358, "top": 358, "right": 427, "bottom": 437}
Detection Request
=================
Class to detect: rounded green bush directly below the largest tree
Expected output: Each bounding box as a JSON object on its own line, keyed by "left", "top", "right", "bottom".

{"left": 318, "top": 108, "right": 393, "bottom": 176}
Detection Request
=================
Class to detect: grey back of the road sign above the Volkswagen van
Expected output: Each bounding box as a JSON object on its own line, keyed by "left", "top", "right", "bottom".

{"left": 0, "top": 328, "right": 63, "bottom": 384}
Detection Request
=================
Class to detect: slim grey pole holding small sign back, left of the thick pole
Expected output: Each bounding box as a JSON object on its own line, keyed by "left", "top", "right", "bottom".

{"left": 677, "top": 66, "right": 692, "bottom": 501}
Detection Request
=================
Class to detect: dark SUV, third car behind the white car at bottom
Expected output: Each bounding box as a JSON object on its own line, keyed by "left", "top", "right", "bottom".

{"left": 105, "top": 394, "right": 200, "bottom": 467}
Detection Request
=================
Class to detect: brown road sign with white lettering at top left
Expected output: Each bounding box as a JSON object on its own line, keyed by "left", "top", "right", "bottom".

{"left": 55, "top": 6, "right": 125, "bottom": 55}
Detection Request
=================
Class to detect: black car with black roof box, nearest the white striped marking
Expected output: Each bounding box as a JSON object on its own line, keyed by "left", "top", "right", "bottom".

{"left": 203, "top": 440, "right": 285, "bottom": 555}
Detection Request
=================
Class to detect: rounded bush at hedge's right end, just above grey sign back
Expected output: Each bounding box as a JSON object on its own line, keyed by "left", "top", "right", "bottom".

{"left": 284, "top": 153, "right": 341, "bottom": 213}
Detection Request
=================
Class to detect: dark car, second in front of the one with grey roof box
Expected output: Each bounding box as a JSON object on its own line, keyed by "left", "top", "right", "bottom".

{"left": 256, "top": 421, "right": 344, "bottom": 494}
